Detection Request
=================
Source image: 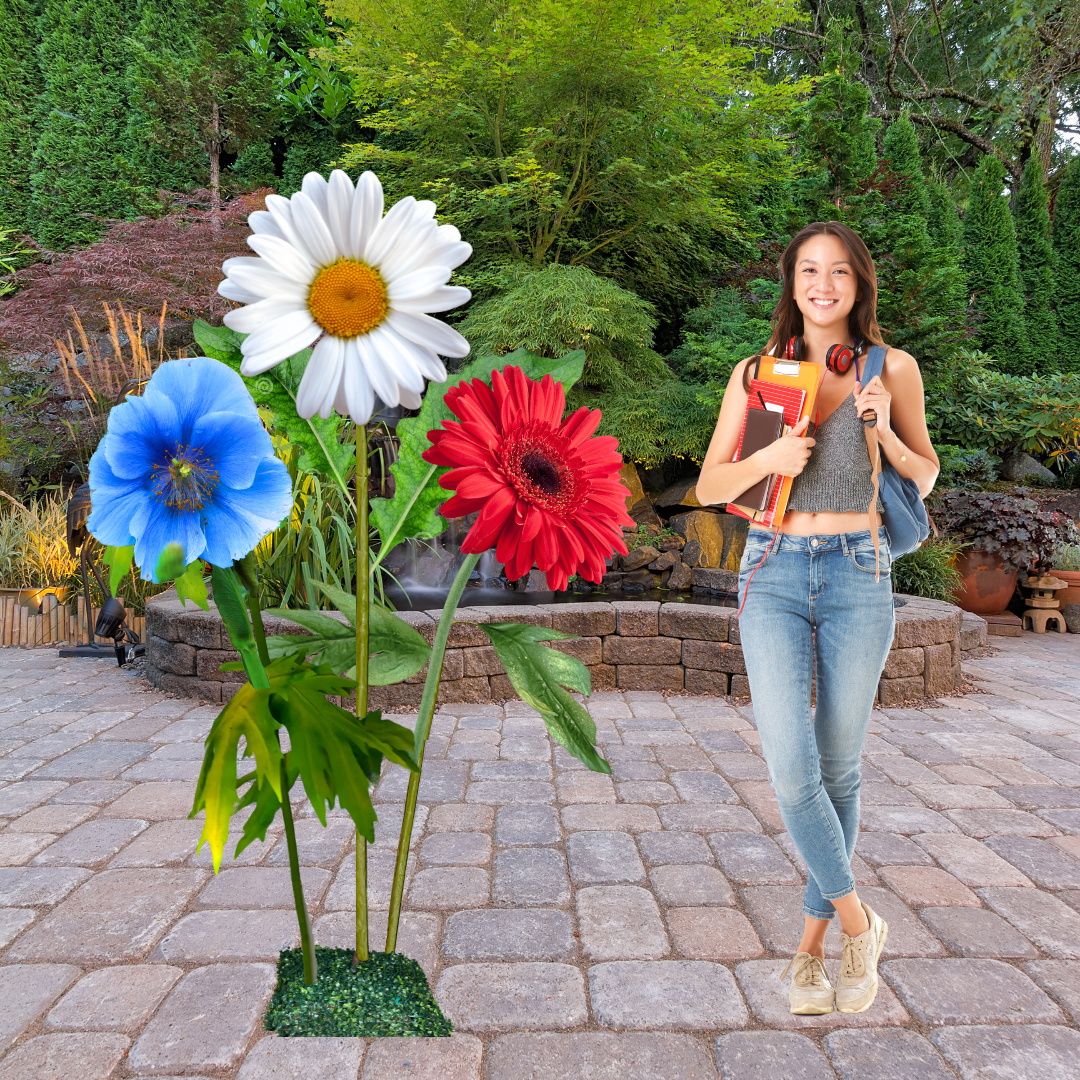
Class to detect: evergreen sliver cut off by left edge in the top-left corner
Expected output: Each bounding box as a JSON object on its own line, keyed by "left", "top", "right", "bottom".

{"left": 0, "top": 0, "right": 41, "bottom": 232}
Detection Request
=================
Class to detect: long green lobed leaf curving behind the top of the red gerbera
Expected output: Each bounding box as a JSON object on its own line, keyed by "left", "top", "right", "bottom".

{"left": 372, "top": 349, "right": 585, "bottom": 552}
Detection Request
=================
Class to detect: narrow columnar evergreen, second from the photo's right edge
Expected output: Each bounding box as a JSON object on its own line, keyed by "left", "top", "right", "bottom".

{"left": 1015, "top": 153, "right": 1059, "bottom": 372}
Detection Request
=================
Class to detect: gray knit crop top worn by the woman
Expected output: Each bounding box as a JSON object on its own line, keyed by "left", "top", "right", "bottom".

{"left": 787, "top": 394, "right": 881, "bottom": 514}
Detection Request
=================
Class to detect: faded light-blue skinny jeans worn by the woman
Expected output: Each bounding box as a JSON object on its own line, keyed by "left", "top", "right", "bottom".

{"left": 739, "top": 529, "right": 894, "bottom": 919}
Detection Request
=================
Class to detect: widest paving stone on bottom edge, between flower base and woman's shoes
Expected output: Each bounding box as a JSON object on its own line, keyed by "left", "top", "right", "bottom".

{"left": 486, "top": 1031, "right": 716, "bottom": 1080}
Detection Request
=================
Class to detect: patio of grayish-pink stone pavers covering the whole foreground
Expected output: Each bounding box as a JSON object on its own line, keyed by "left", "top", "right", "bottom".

{"left": 0, "top": 634, "right": 1080, "bottom": 1080}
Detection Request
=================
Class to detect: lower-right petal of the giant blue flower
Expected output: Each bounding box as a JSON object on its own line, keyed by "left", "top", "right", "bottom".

{"left": 203, "top": 458, "right": 293, "bottom": 566}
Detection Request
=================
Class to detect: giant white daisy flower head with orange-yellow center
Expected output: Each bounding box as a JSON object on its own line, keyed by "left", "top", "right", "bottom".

{"left": 217, "top": 170, "right": 472, "bottom": 423}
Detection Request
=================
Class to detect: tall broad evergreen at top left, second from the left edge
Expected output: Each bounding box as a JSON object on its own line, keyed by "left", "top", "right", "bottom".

{"left": 28, "top": 0, "right": 134, "bottom": 249}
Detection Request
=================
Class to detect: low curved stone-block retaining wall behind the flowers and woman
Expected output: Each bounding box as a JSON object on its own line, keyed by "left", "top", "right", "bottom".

{"left": 147, "top": 592, "right": 986, "bottom": 707}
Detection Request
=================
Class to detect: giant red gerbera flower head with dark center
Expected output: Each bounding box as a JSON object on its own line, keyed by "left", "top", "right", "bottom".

{"left": 423, "top": 367, "right": 634, "bottom": 589}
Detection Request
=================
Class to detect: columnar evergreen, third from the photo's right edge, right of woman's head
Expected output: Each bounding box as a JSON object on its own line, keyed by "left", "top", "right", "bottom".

{"left": 963, "top": 153, "right": 1030, "bottom": 375}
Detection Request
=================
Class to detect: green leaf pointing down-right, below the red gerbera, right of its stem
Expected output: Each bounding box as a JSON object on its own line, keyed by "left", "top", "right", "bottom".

{"left": 480, "top": 622, "right": 611, "bottom": 772}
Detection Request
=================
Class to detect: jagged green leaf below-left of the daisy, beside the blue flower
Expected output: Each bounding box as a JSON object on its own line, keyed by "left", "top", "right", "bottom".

{"left": 192, "top": 319, "right": 356, "bottom": 492}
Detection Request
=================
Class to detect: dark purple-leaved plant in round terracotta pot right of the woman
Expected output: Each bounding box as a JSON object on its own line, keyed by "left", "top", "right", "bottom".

{"left": 934, "top": 491, "right": 1076, "bottom": 615}
